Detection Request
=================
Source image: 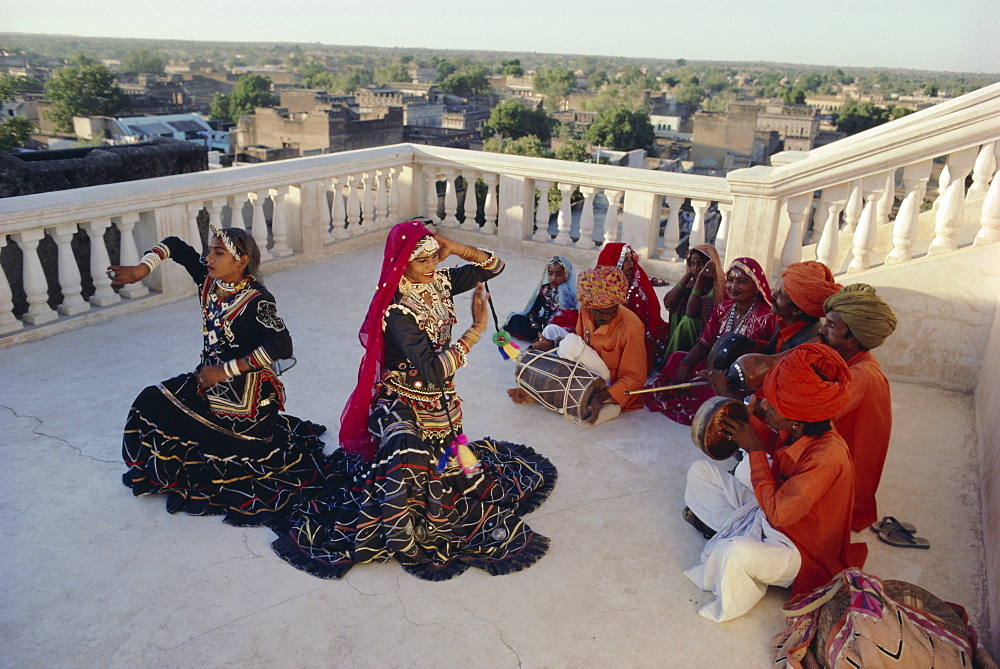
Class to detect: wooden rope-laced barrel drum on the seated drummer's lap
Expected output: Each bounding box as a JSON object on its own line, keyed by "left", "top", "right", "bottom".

{"left": 514, "top": 348, "right": 605, "bottom": 421}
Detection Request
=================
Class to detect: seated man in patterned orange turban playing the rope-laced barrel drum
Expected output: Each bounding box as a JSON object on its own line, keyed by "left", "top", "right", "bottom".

{"left": 507, "top": 266, "right": 647, "bottom": 425}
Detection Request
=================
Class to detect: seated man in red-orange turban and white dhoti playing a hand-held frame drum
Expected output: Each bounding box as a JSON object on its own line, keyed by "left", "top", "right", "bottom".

{"left": 684, "top": 344, "right": 865, "bottom": 622}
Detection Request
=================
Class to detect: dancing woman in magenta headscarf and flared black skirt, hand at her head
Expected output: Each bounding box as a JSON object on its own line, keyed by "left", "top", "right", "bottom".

{"left": 272, "top": 221, "right": 556, "bottom": 581}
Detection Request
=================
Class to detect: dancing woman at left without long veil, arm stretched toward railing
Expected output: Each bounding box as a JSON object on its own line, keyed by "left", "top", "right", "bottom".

{"left": 108, "top": 226, "right": 326, "bottom": 526}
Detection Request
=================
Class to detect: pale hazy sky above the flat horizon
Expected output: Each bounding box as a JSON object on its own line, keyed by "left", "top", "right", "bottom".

{"left": 0, "top": 0, "right": 1000, "bottom": 73}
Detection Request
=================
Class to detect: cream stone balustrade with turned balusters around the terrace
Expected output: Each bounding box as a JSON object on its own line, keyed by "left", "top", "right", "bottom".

{"left": 0, "top": 85, "right": 1000, "bottom": 346}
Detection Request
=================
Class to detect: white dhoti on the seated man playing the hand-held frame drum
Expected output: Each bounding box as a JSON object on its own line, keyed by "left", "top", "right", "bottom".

{"left": 684, "top": 460, "right": 802, "bottom": 623}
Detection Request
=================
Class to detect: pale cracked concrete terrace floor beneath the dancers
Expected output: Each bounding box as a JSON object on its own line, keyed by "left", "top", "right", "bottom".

{"left": 0, "top": 245, "right": 988, "bottom": 667}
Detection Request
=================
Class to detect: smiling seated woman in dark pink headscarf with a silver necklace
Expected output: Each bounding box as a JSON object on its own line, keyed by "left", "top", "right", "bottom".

{"left": 646, "top": 258, "right": 777, "bottom": 425}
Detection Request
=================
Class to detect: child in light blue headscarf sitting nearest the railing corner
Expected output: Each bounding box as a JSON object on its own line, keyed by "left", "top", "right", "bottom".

{"left": 503, "top": 256, "right": 578, "bottom": 342}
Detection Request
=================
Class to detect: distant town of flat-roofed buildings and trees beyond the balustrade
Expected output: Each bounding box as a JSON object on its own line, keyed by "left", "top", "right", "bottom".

{"left": 0, "top": 34, "right": 1000, "bottom": 197}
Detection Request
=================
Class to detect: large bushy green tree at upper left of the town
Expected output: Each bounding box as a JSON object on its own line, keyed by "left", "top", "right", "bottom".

{"left": 45, "top": 64, "right": 129, "bottom": 132}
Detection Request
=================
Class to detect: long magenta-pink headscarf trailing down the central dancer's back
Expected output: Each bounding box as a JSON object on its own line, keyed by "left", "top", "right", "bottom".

{"left": 340, "top": 221, "right": 433, "bottom": 460}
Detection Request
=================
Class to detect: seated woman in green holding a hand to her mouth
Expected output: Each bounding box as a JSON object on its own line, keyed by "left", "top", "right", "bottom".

{"left": 663, "top": 244, "right": 726, "bottom": 356}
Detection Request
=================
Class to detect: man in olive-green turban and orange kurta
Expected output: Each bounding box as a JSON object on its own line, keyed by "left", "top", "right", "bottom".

{"left": 820, "top": 283, "right": 896, "bottom": 531}
